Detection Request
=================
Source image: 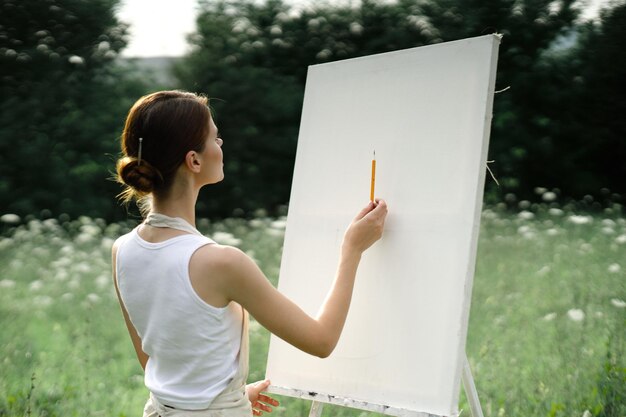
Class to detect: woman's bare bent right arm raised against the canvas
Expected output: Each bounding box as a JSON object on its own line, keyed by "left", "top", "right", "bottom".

{"left": 213, "top": 200, "right": 387, "bottom": 357}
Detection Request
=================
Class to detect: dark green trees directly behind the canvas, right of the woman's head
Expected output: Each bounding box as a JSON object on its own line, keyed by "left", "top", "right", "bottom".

{"left": 177, "top": 0, "right": 578, "bottom": 214}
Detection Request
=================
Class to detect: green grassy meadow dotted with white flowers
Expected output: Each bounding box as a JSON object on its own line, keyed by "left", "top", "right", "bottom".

{"left": 0, "top": 202, "right": 626, "bottom": 417}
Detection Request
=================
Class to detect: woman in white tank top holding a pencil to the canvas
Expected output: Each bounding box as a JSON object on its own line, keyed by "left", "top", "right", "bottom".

{"left": 112, "top": 91, "right": 387, "bottom": 417}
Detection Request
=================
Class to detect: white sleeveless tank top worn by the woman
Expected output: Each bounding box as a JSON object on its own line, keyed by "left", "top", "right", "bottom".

{"left": 116, "top": 229, "right": 243, "bottom": 410}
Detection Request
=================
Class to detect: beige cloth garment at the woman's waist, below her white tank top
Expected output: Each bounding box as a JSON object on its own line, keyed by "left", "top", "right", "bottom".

{"left": 143, "top": 311, "right": 252, "bottom": 417}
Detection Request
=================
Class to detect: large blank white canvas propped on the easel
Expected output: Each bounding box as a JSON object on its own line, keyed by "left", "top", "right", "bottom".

{"left": 266, "top": 35, "right": 499, "bottom": 415}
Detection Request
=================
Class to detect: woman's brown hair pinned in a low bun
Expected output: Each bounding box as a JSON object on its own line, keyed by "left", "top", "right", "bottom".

{"left": 116, "top": 90, "right": 211, "bottom": 203}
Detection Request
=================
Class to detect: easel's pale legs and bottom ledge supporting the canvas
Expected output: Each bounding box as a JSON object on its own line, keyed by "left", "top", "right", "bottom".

{"left": 292, "top": 355, "right": 483, "bottom": 417}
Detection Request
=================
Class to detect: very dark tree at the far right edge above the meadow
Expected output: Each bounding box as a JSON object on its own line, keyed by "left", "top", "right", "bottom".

{"left": 528, "top": 2, "right": 626, "bottom": 200}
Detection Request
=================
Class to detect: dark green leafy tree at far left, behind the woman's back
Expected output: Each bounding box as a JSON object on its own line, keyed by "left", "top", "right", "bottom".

{"left": 0, "top": 0, "right": 145, "bottom": 218}
